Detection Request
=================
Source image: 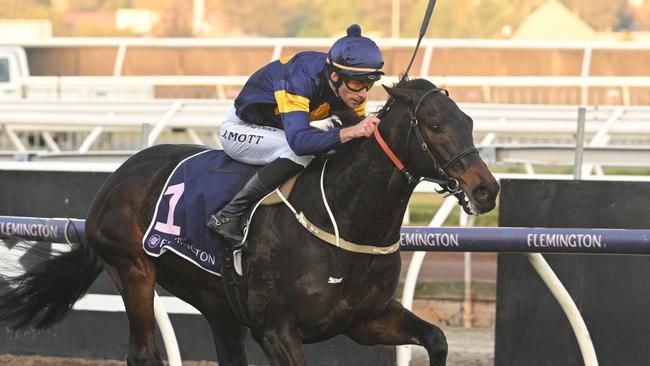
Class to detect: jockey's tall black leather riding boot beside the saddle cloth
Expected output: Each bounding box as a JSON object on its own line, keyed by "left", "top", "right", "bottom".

{"left": 206, "top": 158, "right": 303, "bottom": 247}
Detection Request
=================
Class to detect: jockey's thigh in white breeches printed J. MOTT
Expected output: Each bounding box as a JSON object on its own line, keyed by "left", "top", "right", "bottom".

{"left": 220, "top": 108, "right": 314, "bottom": 166}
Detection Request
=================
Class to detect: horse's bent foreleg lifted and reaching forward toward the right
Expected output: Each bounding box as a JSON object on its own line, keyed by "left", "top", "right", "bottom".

{"left": 346, "top": 300, "right": 447, "bottom": 366}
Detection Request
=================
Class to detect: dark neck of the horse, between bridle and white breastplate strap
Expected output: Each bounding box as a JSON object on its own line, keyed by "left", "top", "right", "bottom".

{"left": 326, "top": 108, "right": 413, "bottom": 244}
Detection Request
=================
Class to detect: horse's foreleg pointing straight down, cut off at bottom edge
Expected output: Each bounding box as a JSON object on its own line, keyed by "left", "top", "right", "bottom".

{"left": 253, "top": 324, "right": 307, "bottom": 366}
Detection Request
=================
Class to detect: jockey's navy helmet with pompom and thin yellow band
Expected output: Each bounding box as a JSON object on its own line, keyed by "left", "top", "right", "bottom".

{"left": 327, "top": 24, "right": 384, "bottom": 82}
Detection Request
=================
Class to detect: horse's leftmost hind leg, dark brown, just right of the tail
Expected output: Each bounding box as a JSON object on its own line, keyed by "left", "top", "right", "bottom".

{"left": 105, "top": 258, "right": 163, "bottom": 366}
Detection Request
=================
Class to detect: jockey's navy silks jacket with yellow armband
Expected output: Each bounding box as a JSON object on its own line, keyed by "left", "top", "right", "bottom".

{"left": 235, "top": 51, "right": 366, "bottom": 155}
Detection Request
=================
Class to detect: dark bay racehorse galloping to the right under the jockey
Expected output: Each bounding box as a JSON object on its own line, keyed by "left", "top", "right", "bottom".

{"left": 0, "top": 79, "right": 499, "bottom": 366}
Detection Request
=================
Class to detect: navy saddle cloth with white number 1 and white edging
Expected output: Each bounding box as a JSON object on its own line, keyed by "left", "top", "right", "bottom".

{"left": 142, "top": 150, "right": 259, "bottom": 275}
